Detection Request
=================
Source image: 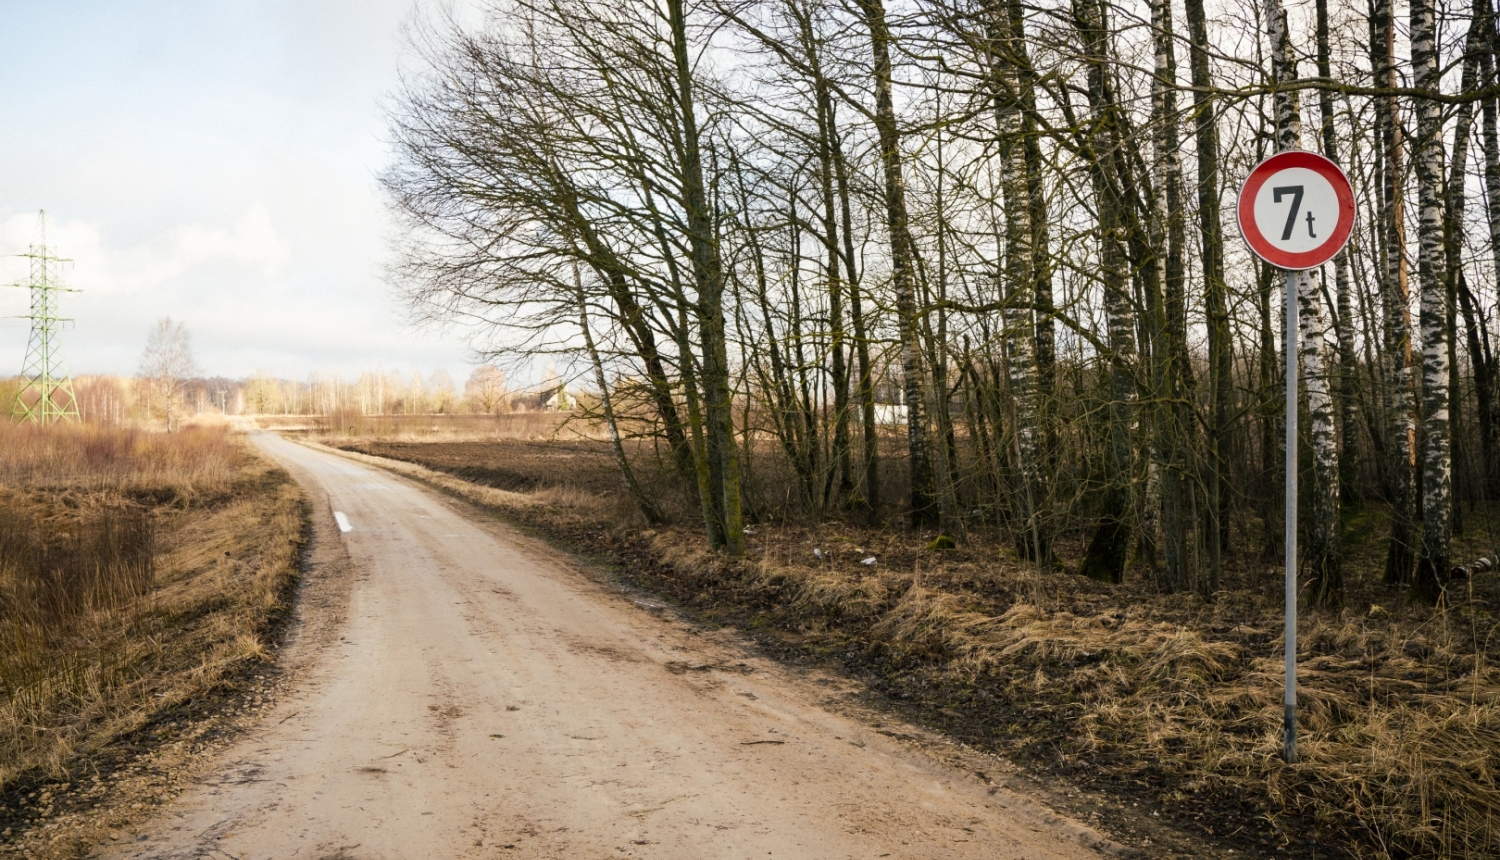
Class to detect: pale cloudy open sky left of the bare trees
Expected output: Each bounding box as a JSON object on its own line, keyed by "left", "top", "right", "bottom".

{"left": 0, "top": 0, "right": 486, "bottom": 384}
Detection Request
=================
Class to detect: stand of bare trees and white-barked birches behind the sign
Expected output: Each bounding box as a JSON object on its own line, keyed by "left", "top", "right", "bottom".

{"left": 383, "top": 0, "right": 1500, "bottom": 609}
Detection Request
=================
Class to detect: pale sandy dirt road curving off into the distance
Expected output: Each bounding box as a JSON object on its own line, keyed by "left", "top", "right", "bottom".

{"left": 101, "top": 435, "right": 1122, "bottom": 860}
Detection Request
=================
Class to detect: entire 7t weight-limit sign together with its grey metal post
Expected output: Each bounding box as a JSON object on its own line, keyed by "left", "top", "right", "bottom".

{"left": 1235, "top": 150, "right": 1355, "bottom": 762}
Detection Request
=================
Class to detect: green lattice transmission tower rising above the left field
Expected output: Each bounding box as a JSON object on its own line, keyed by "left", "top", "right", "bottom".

{"left": 11, "top": 212, "right": 78, "bottom": 425}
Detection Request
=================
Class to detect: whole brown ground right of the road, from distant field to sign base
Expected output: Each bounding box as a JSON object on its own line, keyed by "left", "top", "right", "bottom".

{"left": 326, "top": 437, "right": 1500, "bottom": 857}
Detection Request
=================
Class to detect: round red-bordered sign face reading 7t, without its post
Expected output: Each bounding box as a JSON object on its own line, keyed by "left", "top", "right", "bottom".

{"left": 1236, "top": 150, "right": 1355, "bottom": 269}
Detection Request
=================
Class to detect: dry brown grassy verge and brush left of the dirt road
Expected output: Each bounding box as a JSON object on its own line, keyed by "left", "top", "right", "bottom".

{"left": 0, "top": 425, "right": 306, "bottom": 857}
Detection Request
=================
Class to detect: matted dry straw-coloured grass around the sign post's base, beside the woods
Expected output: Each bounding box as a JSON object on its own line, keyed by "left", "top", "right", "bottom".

{"left": 651, "top": 528, "right": 1500, "bottom": 858}
